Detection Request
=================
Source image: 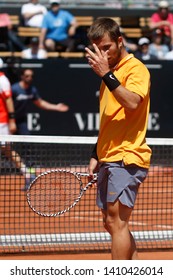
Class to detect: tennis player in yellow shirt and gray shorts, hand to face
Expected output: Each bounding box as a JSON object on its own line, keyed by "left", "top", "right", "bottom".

{"left": 86, "top": 18, "right": 151, "bottom": 260}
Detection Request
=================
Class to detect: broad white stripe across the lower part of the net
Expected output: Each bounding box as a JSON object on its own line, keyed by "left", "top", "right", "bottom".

{"left": 0, "top": 230, "right": 173, "bottom": 246}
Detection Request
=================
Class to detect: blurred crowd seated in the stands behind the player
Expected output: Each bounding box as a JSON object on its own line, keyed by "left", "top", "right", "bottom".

{"left": 0, "top": 0, "right": 173, "bottom": 60}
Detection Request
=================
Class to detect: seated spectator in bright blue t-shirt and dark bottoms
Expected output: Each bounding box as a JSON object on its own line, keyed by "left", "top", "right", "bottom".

{"left": 39, "top": 0, "right": 77, "bottom": 51}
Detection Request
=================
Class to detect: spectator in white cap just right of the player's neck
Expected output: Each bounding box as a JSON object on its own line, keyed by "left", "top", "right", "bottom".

{"left": 134, "top": 37, "right": 157, "bottom": 60}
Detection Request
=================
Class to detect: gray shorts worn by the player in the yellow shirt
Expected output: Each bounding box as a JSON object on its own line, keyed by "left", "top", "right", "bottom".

{"left": 97, "top": 161, "right": 148, "bottom": 210}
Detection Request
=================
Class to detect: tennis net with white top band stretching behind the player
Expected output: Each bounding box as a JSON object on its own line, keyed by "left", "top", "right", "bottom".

{"left": 0, "top": 135, "right": 173, "bottom": 254}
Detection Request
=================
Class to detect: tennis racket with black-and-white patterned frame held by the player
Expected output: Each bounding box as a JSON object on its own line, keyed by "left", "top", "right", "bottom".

{"left": 27, "top": 169, "right": 97, "bottom": 217}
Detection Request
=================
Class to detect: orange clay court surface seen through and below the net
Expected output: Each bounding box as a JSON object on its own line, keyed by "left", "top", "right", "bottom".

{"left": 0, "top": 139, "right": 173, "bottom": 260}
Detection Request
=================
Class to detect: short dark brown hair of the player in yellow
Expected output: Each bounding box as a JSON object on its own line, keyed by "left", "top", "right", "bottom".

{"left": 88, "top": 17, "right": 121, "bottom": 42}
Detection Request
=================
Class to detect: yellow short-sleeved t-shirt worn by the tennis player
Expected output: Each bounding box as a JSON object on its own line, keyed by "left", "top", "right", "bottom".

{"left": 97, "top": 54, "right": 151, "bottom": 168}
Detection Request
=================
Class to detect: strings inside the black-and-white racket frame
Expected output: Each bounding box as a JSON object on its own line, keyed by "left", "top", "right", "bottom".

{"left": 29, "top": 172, "right": 82, "bottom": 215}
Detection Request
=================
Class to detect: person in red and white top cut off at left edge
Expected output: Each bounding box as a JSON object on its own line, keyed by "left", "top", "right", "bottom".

{"left": 0, "top": 59, "right": 35, "bottom": 190}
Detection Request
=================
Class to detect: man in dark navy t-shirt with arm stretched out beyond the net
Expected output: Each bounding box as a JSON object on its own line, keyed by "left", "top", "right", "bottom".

{"left": 12, "top": 69, "right": 69, "bottom": 135}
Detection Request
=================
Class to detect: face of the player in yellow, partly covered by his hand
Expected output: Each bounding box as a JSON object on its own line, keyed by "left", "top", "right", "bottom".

{"left": 93, "top": 34, "right": 123, "bottom": 69}
